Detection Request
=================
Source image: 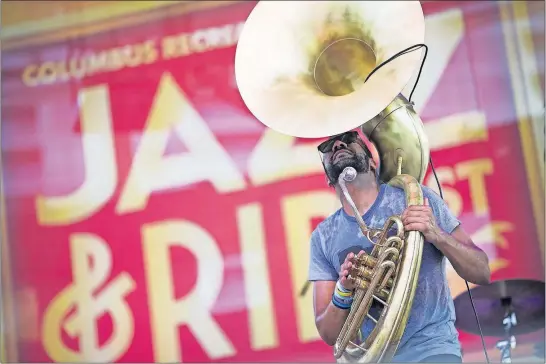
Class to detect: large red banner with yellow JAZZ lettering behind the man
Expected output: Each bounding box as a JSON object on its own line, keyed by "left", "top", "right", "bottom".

{"left": 2, "top": 2, "right": 544, "bottom": 362}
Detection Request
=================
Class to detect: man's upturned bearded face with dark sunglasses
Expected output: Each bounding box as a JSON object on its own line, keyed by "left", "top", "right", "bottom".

{"left": 319, "top": 131, "right": 370, "bottom": 183}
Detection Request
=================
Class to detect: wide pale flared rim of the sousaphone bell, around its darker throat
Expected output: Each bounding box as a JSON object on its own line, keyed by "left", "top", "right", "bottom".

{"left": 235, "top": 1, "right": 425, "bottom": 138}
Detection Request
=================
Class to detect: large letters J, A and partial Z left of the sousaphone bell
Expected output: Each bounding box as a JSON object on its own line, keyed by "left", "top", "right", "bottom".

{"left": 36, "top": 73, "right": 328, "bottom": 225}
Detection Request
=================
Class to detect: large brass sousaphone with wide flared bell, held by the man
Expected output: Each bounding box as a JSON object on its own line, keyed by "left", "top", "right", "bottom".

{"left": 235, "top": 1, "right": 429, "bottom": 362}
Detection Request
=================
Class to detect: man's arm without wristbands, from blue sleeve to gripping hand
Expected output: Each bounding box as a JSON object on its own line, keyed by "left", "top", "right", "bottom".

{"left": 402, "top": 191, "right": 491, "bottom": 285}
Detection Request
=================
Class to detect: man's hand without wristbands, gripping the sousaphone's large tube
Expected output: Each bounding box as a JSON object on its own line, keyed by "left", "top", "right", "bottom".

{"left": 401, "top": 198, "right": 441, "bottom": 244}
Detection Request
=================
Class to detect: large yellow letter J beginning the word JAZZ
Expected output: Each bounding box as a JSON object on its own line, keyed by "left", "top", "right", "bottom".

{"left": 36, "top": 86, "right": 117, "bottom": 225}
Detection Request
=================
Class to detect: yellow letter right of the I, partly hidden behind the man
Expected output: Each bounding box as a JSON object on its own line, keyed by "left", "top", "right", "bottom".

{"left": 281, "top": 191, "right": 340, "bottom": 343}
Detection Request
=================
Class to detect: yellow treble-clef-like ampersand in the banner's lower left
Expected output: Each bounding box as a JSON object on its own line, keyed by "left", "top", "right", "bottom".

{"left": 42, "top": 234, "right": 135, "bottom": 363}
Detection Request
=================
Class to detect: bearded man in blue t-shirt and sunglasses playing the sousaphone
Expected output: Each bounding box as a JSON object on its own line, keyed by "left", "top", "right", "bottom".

{"left": 309, "top": 131, "right": 490, "bottom": 363}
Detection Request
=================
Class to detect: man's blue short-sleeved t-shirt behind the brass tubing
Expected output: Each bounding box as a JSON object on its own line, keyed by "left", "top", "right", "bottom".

{"left": 309, "top": 184, "right": 461, "bottom": 362}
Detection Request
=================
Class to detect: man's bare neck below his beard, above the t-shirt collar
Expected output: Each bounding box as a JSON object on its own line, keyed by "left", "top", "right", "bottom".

{"left": 336, "top": 173, "right": 379, "bottom": 216}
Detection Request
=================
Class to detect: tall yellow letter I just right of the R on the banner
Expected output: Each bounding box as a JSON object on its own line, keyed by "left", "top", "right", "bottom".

{"left": 237, "top": 204, "right": 279, "bottom": 350}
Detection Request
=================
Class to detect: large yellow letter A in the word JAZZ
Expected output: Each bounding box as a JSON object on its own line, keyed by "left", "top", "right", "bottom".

{"left": 117, "top": 74, "right": 246, "bottom": 213}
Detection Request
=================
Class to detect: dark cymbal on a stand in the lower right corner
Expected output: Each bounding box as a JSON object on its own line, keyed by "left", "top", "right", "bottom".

{"left": 454, "top": 279, "right": 544, "bottom": 336}
